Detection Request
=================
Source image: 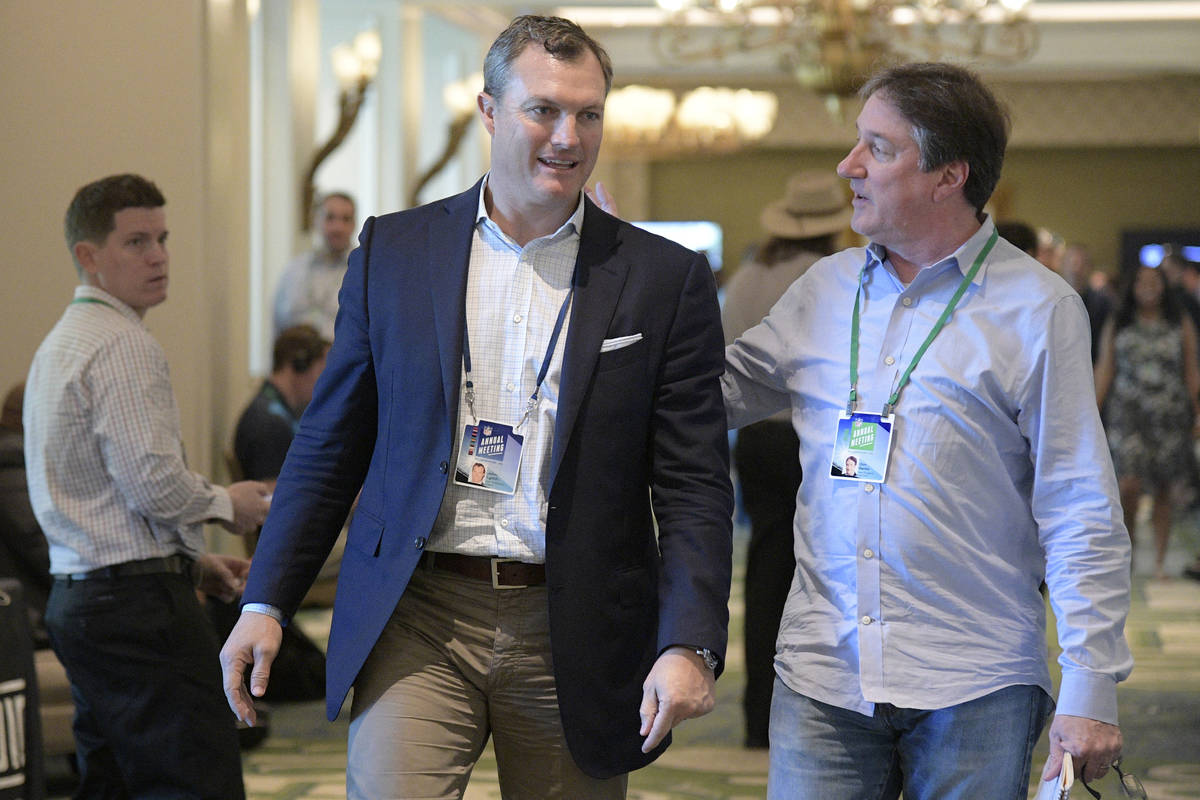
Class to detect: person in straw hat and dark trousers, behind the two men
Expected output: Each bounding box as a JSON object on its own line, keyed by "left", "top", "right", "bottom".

{"left": 721, "top": 169, "right": 851, "bottom": 748}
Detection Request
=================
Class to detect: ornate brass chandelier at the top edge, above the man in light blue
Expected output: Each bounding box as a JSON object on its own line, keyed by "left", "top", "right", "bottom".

{"left": 654, "top": 0, "right": 1038, "bottom": 97}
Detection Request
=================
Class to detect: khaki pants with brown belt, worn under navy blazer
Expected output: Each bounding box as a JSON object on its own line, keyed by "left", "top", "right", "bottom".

{"left": 347, "top": 566, "right": 638, "bottom": 800}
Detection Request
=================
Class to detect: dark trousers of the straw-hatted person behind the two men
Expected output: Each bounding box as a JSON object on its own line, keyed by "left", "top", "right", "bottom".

{"left": 733, "top": 420, "right": 800, "bottom": 747}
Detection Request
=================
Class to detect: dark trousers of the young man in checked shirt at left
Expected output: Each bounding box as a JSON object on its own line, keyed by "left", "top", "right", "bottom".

{"left": 46, "top": 573, "right": 245, "bottom": 800}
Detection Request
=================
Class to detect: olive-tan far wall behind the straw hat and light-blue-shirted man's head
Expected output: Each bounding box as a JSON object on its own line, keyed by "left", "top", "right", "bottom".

{"left": 649, "top": 145, "right": 1200, "bottom": 281}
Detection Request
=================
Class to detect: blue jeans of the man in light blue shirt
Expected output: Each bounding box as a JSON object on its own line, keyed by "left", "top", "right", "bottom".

{"left": 767, "top": 679, "right": 1054, "bottom": 800}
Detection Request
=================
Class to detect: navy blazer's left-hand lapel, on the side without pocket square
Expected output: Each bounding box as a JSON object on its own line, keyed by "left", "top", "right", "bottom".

{"left": 421, "top": 180, "right": 482, "bottom": 433}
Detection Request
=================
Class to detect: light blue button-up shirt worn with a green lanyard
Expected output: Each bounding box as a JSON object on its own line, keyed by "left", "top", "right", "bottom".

{"left": 722, "top": 219, "right": 1133, "bottom": 723}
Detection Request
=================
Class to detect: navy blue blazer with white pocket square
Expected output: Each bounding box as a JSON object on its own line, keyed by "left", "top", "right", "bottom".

{"left": 244, "top": 184, "right": 732, "bottom": 777}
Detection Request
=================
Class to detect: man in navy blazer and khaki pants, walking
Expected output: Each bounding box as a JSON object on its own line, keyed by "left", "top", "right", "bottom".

{"left": 221, "top": 17, "right": 732, "bottom": 798}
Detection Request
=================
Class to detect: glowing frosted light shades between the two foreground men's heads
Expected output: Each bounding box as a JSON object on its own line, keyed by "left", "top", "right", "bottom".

{"left": 605, "top": 85, "right": 779, "bottom": 150}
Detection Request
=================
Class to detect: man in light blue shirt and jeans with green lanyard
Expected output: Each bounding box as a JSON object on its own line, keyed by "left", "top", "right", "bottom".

{"left": 722, "top": 64, "right": 1133, "bottom": 800}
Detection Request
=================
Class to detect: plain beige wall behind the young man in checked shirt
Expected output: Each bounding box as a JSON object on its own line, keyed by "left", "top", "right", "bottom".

{"left": 0, "top": 0, "right": 247, "bottom": 525}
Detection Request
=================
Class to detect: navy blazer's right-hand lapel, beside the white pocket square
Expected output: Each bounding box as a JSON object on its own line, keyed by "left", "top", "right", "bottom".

{"left": 550, "top": 200, "right": 629, "bottom": 486}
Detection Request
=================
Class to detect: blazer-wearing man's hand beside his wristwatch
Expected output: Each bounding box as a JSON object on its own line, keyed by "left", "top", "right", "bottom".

{"left": 638, "top": 648, "right": 716, "bottom": 753}
